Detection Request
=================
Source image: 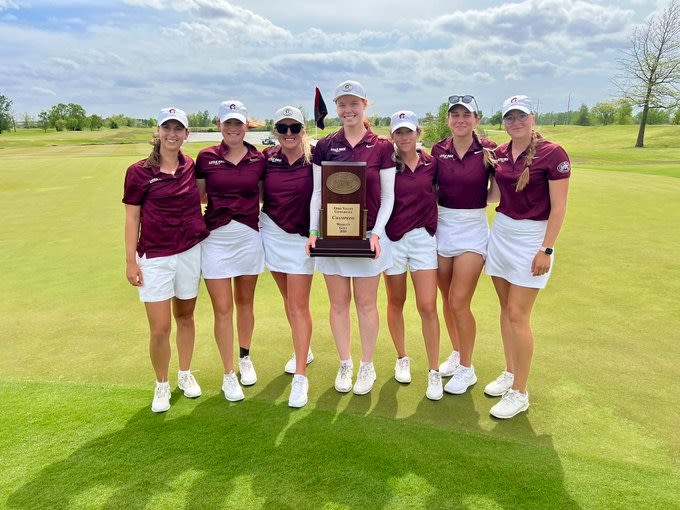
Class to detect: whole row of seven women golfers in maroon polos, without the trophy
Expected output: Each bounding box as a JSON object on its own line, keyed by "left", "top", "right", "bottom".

{"left": 123, "top": 80, "right": 571, "bottom": 418}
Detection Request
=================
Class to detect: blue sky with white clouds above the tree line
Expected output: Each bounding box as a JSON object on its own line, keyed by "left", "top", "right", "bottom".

{"left": 0, "top": 0, "right": 667, "bottom": 119}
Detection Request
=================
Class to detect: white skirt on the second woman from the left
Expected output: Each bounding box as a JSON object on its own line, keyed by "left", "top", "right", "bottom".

{"left": 201, "top": 220, "right": 264, "bottom": 280}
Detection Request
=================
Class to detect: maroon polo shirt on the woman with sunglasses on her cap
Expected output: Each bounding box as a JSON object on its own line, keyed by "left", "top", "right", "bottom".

{"left": 431, "top": 137, "right": 496, "bottom": 209}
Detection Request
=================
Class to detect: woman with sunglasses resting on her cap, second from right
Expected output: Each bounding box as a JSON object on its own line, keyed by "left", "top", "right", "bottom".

{"left": 432, "top": 95, "right": 497, "bottom": 394}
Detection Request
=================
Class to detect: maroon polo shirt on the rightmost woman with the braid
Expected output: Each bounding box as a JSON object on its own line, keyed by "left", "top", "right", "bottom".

{"left": 496, "top": 138, "right": 571, "bottom": 220}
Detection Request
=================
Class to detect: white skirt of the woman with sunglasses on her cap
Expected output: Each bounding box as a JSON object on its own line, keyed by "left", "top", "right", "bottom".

{"left": 437, "top": 206, "right": 489, "bottom": 257}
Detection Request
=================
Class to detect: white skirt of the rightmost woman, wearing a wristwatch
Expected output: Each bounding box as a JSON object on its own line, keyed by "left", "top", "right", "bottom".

{"left": 486, "top": 213, "right": 555, "bottom": 289}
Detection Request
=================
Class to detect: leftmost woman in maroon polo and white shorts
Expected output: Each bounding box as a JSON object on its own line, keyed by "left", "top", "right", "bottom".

{"left": 123, "top": 108, "right": 208, "bottom": 413}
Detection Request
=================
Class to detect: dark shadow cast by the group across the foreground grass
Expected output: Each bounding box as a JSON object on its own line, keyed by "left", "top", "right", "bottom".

{"left": 7, "top": 377, "right": 579, "bottom": 510}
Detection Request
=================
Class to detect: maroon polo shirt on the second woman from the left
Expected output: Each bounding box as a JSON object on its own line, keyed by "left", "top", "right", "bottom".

{"left": 196, "top": 142, "right": 264, "bottom": 230}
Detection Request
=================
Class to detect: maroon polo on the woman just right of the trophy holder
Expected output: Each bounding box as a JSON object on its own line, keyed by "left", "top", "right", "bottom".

{"left": 385, "top": 151, "right": 437, "bottom": 241}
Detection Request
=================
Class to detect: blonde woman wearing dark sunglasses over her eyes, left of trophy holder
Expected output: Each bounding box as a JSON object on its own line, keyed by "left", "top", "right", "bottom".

{"left": 260, "top": 106, "right": 314, "bottom": 407}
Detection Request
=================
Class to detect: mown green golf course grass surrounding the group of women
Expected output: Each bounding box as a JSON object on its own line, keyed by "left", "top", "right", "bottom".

{"left": 0, "top": 128, "right": 680, "bottom": 509}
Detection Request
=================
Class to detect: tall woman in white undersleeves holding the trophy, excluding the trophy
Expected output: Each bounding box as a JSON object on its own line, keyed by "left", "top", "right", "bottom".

{"left": 309, "top": 80, "right": 395, "bottom": 395}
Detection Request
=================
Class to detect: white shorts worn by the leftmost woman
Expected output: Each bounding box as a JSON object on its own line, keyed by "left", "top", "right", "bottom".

{"left": 136, "top": 244, "right": 201, "bottom": 303}
